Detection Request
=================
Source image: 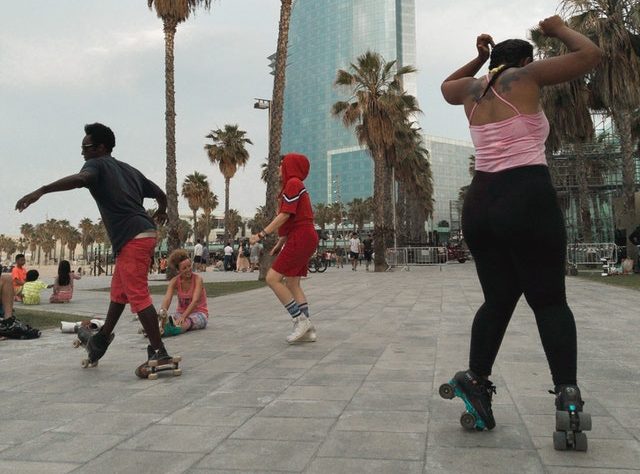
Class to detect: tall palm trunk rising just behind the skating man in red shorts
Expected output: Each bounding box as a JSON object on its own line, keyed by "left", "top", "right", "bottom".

{"left": 163, "top": 18, "right": 180, "bottom": 252}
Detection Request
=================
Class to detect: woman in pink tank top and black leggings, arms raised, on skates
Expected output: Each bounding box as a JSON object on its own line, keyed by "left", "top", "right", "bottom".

{"left": 441, "top": 16, "right": 602, "bottom": 450}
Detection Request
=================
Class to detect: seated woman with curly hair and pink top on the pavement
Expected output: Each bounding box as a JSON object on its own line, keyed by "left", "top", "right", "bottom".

{"left": 159, "top": 249, "right": 209, "bottom": 336}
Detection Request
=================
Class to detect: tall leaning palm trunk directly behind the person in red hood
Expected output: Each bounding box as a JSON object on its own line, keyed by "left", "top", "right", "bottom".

{"left": 259, "top": 0, "right": 292, "bottom": 281}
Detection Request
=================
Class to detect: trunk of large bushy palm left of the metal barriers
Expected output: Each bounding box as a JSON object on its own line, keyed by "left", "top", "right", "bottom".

{"left": 373, "top": 150, "right": 389, "bottom": 272}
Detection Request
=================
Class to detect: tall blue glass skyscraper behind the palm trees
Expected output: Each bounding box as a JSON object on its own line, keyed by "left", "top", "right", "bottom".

{"left": 281, "top": 0, "right": 416, "bottom": 204}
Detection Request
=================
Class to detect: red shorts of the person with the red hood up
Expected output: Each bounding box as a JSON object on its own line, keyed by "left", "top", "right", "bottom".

{"left": 271, "top": 226, "right": 318, "bottom": 276}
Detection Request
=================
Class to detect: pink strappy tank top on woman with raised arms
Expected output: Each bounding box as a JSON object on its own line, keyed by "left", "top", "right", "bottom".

{"left": 469, "top": 76, "right": 549, "bottom": 173}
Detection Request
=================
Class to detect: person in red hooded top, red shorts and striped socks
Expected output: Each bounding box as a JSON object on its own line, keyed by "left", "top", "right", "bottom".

{"left": 251, "top": 153, "right": 318, "bottom": 344}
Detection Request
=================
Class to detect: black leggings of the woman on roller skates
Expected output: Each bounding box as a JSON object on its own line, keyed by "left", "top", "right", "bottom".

{"left": 462, "top": 166, "right": 577, "bottom": 385}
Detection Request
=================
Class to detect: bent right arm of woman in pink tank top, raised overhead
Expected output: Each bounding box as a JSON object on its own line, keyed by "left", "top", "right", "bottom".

{"left": 524, "top": 15, "right": 602, "bottom": 86}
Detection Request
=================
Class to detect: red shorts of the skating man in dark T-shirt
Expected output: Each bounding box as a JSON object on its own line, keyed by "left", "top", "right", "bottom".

{"left": 111, "top": 238, "right": 156, "bottom": 313}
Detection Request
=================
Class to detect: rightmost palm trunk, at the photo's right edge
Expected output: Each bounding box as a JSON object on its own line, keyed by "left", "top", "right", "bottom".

{"left": 611, "top": 108, "right": 638, "bottom": 260}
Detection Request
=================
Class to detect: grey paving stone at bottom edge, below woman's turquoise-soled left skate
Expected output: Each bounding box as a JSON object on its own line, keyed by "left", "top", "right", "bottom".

{"left": 424, "top": 447, "right": 545, "bottom": 474}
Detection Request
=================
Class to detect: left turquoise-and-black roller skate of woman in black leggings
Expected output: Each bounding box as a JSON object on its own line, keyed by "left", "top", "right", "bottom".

{"left": 439, "top": 370, "right": 496, "bottom": 431}
